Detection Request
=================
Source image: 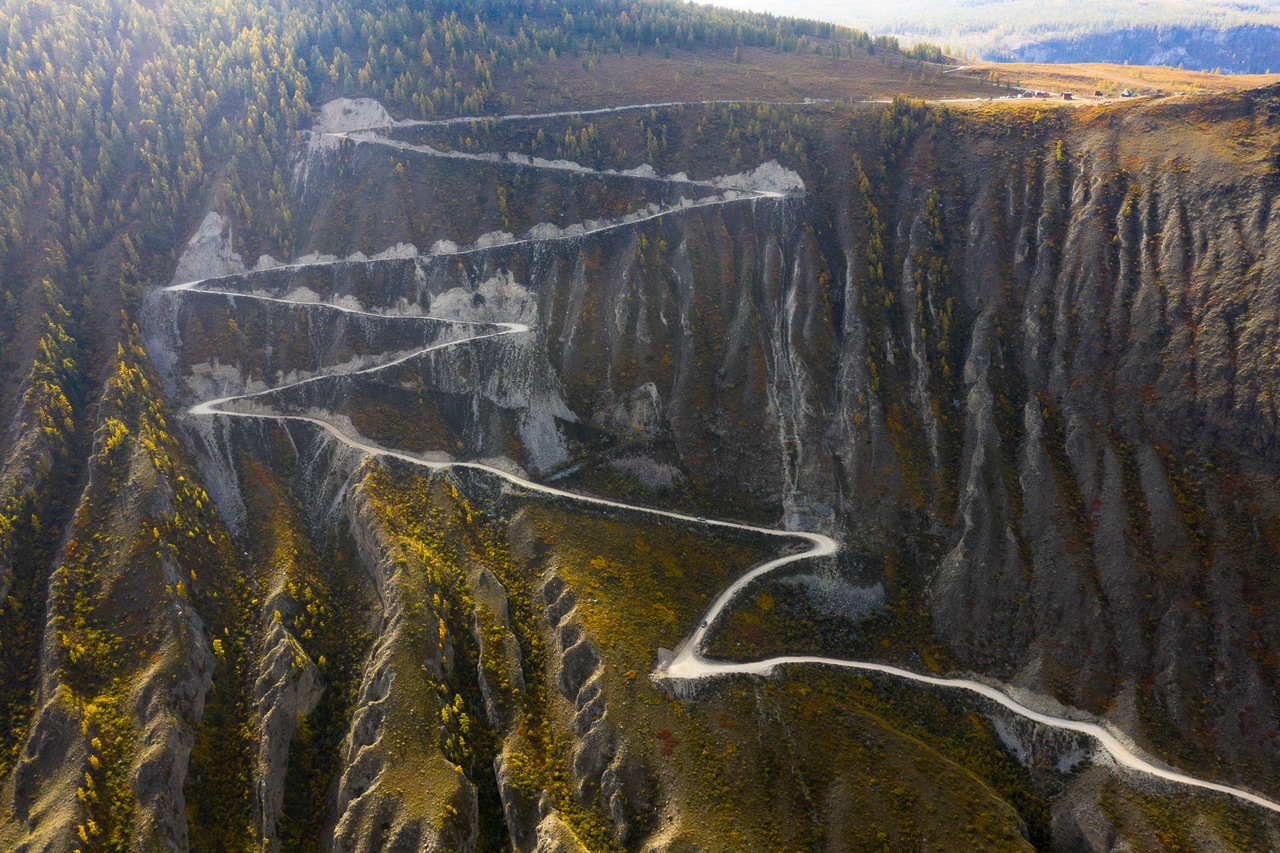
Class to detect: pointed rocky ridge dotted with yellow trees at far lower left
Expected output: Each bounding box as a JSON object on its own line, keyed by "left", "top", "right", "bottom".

{"left": 0, "top": 339, "right": 236, "bottom": 849}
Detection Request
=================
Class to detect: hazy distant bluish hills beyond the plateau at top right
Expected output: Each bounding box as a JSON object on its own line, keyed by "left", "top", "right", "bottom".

{"left": 711, "top": 0, "right": 1280, "bottom": 74}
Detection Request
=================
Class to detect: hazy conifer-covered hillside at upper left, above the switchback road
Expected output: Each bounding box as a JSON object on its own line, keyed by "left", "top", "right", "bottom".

{"left": 0, "top": 3, "right": 942, "bottom": 691}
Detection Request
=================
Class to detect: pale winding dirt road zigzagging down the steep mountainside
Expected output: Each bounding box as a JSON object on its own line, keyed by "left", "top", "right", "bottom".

{"left": 165, "top": 108, "right": 1280, "bottom": 813}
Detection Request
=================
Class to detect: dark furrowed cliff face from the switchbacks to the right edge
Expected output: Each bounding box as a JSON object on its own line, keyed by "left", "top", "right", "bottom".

{"left": 240, "top": 104, "right": 1280, "bottom": 799}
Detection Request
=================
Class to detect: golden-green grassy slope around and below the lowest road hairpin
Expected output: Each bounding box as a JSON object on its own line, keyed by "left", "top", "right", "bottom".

{"left": 513, "top": 503, "right": 1029, "bottom": 853}
